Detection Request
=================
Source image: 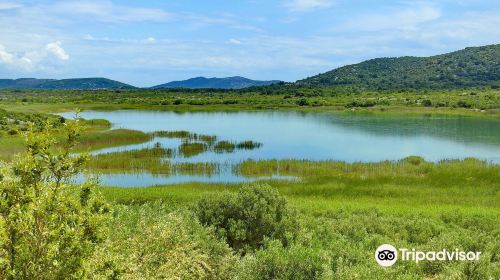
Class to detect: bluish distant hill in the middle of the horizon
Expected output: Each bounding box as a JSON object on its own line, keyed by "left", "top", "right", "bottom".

{"left": 152, "top": 76, "right": 279, "bottom": 89}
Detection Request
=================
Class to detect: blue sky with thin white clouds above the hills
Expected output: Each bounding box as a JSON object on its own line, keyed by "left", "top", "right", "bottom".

{"left": 0, "top": 0, "right": 500, "bottom": 86}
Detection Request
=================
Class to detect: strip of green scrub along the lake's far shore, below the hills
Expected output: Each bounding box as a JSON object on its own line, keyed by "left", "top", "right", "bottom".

{"left": 0, "top": 85, "right": 500, "bottom": 110}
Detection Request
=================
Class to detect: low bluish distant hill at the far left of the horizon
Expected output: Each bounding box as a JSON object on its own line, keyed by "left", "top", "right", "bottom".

{"left": 0, "top": 78, "right": 135, "bottom": 89}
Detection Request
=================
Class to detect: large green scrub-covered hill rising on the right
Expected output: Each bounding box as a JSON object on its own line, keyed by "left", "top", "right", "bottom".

{"left": 296, "top": 44, "right": 500, "bottom": 90}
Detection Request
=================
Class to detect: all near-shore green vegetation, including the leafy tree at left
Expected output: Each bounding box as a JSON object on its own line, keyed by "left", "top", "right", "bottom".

{"left": 0, "top": 123, "right": 500, "bottom": 279}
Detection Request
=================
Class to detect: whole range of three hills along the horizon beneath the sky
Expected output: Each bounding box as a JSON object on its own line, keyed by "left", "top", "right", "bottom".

{"left": 0, "top": 44, "right": 500, "bottom": 90}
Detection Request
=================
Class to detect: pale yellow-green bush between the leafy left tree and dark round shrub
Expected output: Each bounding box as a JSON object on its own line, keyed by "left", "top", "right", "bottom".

{"left": 88, "top": 202, "right": 237, "bottom": 279}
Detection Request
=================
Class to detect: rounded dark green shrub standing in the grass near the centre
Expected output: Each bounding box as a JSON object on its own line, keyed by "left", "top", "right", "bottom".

{"left": 193, "top": 184, "right": 297, "bottom": 254}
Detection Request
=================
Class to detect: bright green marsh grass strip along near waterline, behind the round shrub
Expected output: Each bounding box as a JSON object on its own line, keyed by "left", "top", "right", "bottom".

{"left": 98, "top": 159, "right": 500, "bottom": 218}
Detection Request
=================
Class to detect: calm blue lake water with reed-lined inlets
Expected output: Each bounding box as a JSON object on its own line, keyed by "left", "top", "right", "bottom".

{"left": 61, "top": 110, "right": 500, "bottom": 187}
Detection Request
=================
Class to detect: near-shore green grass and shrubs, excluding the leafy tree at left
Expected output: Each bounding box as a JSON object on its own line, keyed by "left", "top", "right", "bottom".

{"left": 79, "top": 157, "right": 500, "bottom": 279}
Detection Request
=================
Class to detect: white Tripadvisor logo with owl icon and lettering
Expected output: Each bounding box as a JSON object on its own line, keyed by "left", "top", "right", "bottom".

{"left": 375, "top": 244, "right": 481, "bottom": 267}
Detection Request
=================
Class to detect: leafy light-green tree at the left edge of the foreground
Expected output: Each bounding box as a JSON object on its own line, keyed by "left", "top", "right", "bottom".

{"left": 0, "top": 117, "right": 109, "bottom": 279}
